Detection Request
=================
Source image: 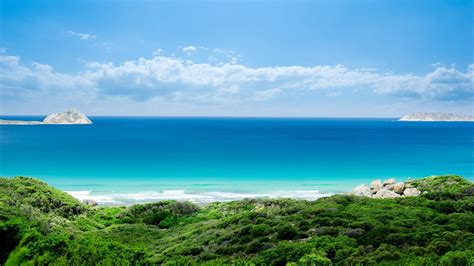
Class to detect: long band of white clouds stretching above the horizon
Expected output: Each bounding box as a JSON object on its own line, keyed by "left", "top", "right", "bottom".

{"left": 0, "top": 49, "right": 474, "bottom": 115}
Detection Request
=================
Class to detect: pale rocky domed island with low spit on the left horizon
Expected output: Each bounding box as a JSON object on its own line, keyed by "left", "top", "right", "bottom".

{"left": 0, "top": 109, "right": 92, "bottom": 125}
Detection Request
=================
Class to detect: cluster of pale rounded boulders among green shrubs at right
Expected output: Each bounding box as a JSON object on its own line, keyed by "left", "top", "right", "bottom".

{"left": 349, "top": 178, "right": 421, "bottom": 199}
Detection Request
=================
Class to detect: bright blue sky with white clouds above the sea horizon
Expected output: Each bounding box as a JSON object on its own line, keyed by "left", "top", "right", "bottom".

{"left": 0, "top": 0, "right": 474, "bottom": 117}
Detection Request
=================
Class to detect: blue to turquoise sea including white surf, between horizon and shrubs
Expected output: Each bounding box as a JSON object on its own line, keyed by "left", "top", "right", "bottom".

{"left": 0, "top": 116, "right": 474, "bottom": 204}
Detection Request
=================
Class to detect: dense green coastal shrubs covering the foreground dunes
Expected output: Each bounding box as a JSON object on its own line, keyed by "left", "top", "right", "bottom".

{"left": 0, "top": 176, "right": 474, "bottom": 265}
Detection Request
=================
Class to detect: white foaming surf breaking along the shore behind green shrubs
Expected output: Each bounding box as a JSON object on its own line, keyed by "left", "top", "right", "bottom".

{"left": 66, "top": 190, "right": 333, "bottom": 205}
